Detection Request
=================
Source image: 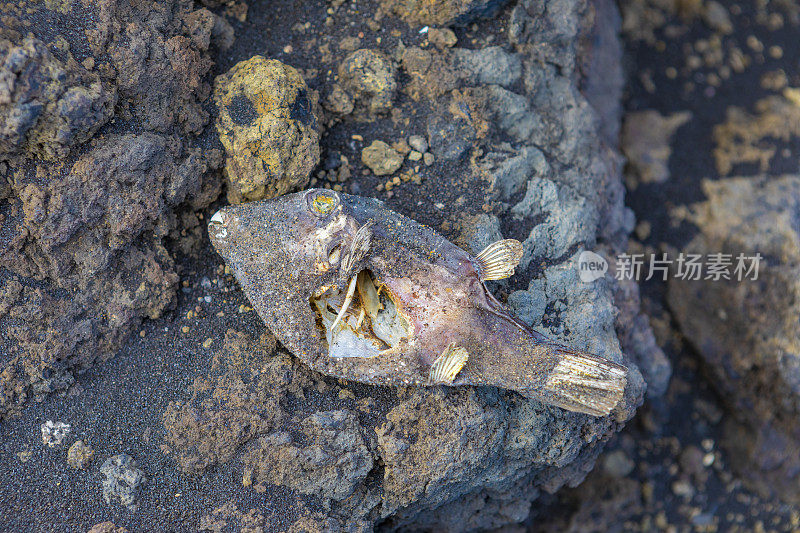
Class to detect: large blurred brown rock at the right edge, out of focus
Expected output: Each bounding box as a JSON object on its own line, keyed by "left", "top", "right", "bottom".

{"left": 668, "top": 175, "right": 800, "bottom": 503}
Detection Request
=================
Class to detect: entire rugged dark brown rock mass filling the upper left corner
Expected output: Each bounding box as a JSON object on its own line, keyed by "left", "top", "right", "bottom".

{"left": 0, "top": 0, "right": 223, "bottom": 417}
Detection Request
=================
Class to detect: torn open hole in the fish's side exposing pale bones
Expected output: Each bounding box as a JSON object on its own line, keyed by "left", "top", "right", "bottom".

{"left": 311, "top": 270, "right": 414, "bottom": 358}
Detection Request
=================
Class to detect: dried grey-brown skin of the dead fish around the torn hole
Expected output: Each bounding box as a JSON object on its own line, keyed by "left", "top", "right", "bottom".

{"left": 209, "top": 189, "right": 627, "bottom": 416}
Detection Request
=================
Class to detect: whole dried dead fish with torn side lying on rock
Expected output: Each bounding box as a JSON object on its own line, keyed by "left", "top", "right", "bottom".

{"left": 208, "top": 189, "right": 627, "bottom": 416}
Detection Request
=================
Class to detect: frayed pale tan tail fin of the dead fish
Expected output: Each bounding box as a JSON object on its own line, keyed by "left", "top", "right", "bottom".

{"left": 542, "top": 347, "right": 628, "bottom": 416}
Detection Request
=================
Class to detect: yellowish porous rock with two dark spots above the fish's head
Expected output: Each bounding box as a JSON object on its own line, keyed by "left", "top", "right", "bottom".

{"left": 214, "top": 56, "right": 321, "bottom": 203}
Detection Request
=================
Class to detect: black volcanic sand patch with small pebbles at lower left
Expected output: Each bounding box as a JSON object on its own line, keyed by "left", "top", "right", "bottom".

{"left": 0, "top": 247, "right": 276, "bottom": 531}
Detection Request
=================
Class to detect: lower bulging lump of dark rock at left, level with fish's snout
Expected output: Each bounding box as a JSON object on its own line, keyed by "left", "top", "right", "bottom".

{"left": 0, "top": 133, "right": 218, "bottom": 412}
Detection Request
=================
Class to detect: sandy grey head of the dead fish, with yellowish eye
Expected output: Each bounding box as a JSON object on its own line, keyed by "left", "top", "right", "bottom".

{"left": 208, "top": 189, "right": 390, "bottom": 366}
